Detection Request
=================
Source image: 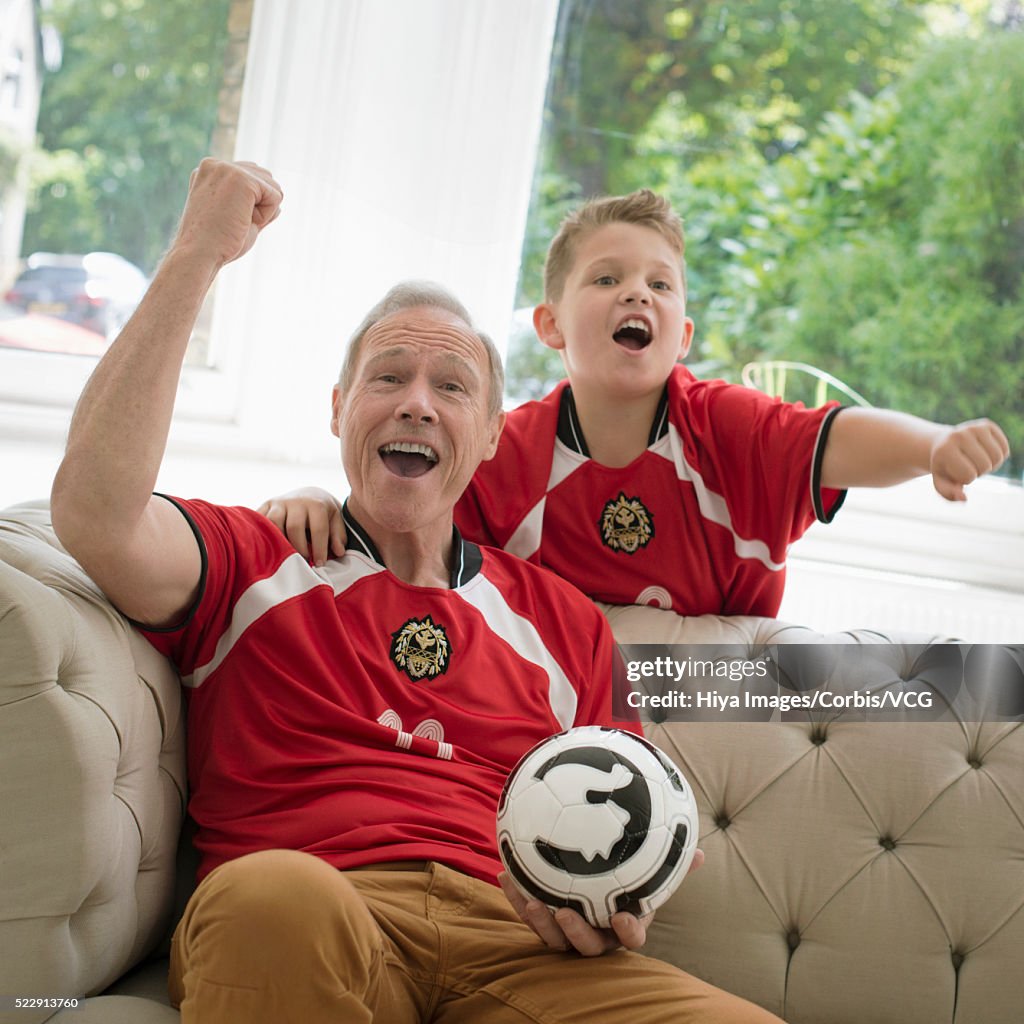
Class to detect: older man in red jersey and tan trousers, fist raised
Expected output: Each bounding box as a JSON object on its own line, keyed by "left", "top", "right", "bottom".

{"left": 52, "top": 161, "right": 774, "bottom": 1024}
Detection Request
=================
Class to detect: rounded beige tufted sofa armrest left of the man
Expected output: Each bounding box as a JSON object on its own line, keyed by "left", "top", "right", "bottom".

{"left": 0, "top": 503, "right": 185, "bottom": 995}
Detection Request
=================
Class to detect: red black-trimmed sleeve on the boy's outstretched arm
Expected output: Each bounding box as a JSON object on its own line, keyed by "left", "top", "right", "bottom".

{"left": 683, "top": 381, "right": 846, "bottom": 561}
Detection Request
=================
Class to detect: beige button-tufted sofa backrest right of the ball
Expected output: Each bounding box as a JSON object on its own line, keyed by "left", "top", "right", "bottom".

{"left": 605, "top": 607, "right": 1024, "bottom": 1024}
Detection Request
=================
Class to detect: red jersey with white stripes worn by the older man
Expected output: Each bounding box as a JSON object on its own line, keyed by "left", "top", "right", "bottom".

{"left": 139, "top": 501, "right": 626, "bottom": 883}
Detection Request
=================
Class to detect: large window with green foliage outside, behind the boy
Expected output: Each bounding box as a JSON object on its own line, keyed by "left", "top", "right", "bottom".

{"left": 509, "top": 0, "right": 1024, "bottom": 481}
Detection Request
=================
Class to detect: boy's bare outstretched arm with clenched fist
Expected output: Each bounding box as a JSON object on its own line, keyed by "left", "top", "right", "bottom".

{"left": 821, "top": 409, "right": 1010, "bottom": 502}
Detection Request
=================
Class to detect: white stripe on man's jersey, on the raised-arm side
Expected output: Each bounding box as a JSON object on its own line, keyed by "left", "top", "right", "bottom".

{"left": 181, "top": 552, "right": 383, "bottom": 687}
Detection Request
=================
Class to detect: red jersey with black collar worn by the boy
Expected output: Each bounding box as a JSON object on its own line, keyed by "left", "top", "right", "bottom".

{"left": 456, "top": 366, "right": 845, "bottom": 616}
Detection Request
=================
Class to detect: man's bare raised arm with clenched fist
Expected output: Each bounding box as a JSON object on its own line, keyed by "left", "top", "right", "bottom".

{"left": 51, "top": 160, "right": 282, "bottom": 626}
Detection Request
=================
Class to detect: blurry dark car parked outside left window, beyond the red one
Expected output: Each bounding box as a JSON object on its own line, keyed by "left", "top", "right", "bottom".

{"left": 4, "top": 252, "right": 148, "bottom": 340}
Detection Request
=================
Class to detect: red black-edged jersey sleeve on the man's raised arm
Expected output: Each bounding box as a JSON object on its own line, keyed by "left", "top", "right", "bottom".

{"left": 141, "top": 498, "right": 301, "bottom": 679}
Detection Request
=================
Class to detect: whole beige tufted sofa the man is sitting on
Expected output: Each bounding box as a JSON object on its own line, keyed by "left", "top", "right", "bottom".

{"left": 0, "top": 505, "right": 1024, "bottom": 1024}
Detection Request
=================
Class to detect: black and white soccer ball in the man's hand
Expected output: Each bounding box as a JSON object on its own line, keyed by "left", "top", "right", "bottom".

{"left": 498, "top": 725, "right": 697, "bottom": 928}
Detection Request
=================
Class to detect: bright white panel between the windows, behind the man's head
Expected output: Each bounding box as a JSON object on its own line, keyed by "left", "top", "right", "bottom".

{"left": 214, "top": 0, "right": 557, "bottom": 460}
